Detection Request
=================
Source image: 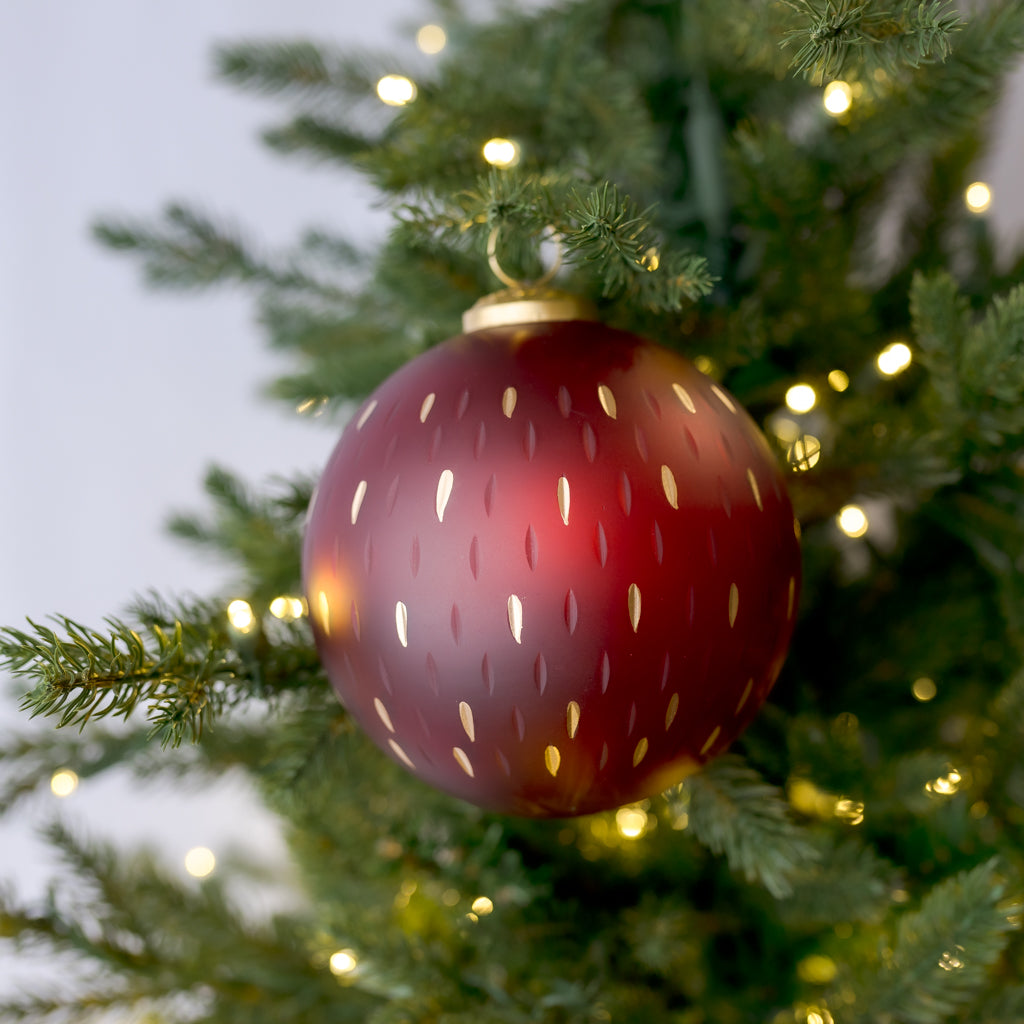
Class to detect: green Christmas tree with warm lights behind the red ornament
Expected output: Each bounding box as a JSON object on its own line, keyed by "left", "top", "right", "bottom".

{"left": 0, "top": 0, "right": 1024, "bottom": 1024}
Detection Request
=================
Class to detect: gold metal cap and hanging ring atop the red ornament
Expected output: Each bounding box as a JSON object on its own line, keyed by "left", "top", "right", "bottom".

{"left": 462, "top": 227, "right": 599, "bottom": 334}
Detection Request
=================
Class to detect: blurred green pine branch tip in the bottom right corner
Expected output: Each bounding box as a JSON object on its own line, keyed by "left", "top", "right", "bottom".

{"left": 850, "top": 861, "right": 1015, "bottom": 1024}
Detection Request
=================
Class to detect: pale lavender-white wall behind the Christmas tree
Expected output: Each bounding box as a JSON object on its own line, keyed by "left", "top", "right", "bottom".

{"left": 0, "top": 0, "right": 1024, "bottom": 990}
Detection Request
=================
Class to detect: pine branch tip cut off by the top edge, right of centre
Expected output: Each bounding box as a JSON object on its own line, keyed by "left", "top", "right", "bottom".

{"left": 782, "top": 0, "right": 963, "bottom": 78}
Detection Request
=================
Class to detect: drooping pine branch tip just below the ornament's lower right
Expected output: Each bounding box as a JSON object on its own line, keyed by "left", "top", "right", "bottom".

{"left": 683, "top": 755, "right": 818, "bottom": 899}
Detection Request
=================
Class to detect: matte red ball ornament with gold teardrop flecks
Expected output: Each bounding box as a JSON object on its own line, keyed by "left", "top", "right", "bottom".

{"left": 303, "top": 292, "right": 800, "bottom": 816}
